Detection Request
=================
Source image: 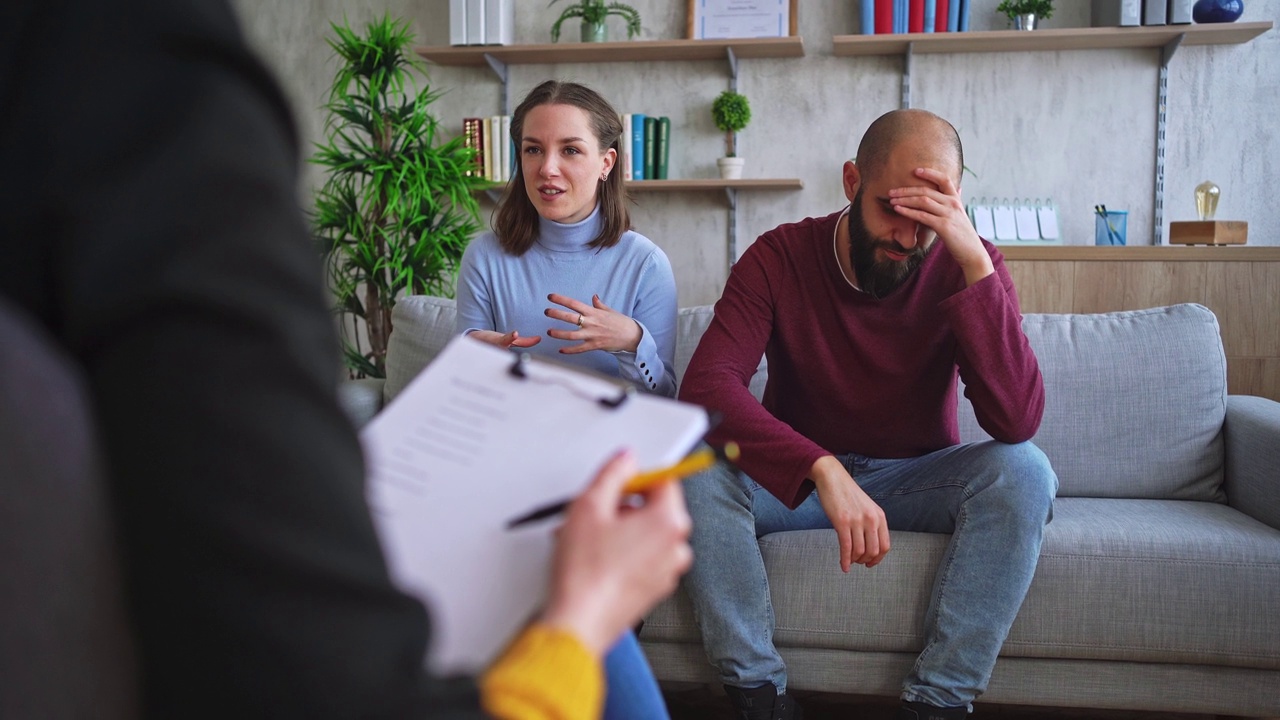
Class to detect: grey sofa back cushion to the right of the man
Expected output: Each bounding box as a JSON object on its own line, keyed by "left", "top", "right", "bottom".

{"left": 960, "top": 304, "right": 1226, "bottom": 502}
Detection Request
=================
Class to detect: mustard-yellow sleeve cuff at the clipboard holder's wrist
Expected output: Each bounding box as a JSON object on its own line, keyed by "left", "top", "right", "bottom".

{"left": 480, "top": 625, "right": 604, "bottom": 720}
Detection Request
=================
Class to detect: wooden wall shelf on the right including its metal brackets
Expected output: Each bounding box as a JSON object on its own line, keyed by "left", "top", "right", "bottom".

{"left": 832, "top": 20, "right": 1274, "bottom": 245}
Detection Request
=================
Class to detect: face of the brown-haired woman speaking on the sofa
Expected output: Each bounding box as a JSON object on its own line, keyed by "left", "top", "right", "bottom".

{"left": 520, "top": 105, "right": 617, "bottom": 224}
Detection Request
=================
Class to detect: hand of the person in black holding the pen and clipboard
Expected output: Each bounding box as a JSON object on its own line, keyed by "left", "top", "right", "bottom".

{"left": 540, "top": 452, "right": 694, "bottom": 656}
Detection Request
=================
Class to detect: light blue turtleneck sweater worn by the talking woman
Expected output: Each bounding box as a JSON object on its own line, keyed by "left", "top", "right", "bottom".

{"left": 457, "top": 205, "right": 677, "bottom": 397}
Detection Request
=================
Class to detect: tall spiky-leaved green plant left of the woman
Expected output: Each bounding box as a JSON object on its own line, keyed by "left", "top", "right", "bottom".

{"left": 311, "top": 17, "right": 489, "bottom": 378}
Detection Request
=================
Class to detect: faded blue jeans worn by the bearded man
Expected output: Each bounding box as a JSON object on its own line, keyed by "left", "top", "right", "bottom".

{"left": 684, "top": 442, "right": 1057, "bottom": 707}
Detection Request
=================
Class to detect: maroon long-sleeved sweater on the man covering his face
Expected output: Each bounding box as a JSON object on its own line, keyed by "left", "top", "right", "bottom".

{"left": 680, "top": 207, "right": 1044, "bottom": 507}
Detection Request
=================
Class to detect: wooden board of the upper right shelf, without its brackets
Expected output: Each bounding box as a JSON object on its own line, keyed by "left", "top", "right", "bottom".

{"left": 832, "top": 22, "right": 1272, "bottom": 58}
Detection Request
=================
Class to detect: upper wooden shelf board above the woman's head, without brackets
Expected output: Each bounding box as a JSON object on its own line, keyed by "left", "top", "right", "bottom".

{"left": 416, "top": 36, "right": 804, "bottom": 65}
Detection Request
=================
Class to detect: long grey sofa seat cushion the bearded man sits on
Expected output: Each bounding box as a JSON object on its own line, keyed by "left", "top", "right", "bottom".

{"left": 641, "top": 498, "right": 1280, "bottom": 670}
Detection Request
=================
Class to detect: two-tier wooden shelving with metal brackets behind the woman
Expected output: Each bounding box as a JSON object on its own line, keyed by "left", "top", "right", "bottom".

{"left": 427, "top": 36, "right": 804, "bottom": 265}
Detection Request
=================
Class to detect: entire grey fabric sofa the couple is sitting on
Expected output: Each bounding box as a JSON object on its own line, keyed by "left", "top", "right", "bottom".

{"left": 344, "top": 297, "right": 1280, "bottom": 716}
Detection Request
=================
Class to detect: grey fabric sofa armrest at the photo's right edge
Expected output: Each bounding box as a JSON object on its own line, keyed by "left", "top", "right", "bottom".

{"left": 1222, "top": 395, "right": 1280, "bottom": 528}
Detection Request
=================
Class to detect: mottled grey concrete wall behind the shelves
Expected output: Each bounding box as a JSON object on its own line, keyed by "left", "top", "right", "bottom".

{"left": 236, "top": 0, "right": 1280, "bottom": 305}
